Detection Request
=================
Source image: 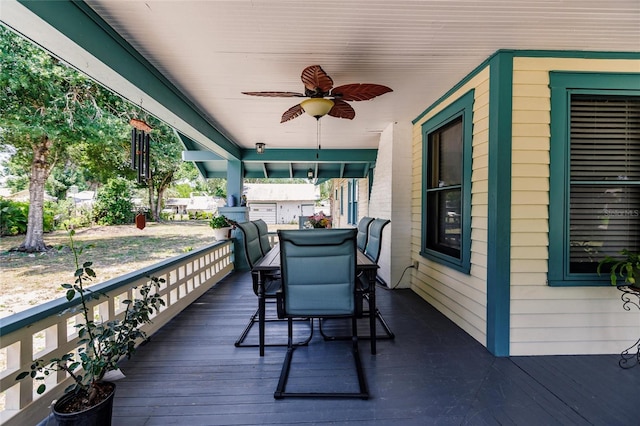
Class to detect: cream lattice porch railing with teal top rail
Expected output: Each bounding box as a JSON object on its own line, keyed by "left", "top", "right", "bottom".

{"left": 0, "top": 240, "right": 234, "bottom": 426}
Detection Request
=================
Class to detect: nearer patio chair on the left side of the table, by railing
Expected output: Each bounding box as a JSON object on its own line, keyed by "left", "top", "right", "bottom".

{"left": 234, "top": 222, "right": 311, "bottom": 348}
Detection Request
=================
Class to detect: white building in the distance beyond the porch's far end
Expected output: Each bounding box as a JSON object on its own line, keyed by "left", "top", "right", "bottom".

{"left": 244, "top": 183, "right": 318, "bottom": 224}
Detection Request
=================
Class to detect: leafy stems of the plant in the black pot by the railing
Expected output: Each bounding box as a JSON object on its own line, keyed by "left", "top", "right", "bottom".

{"left": 16, "top": 231, "right": 165, "bottom": 407}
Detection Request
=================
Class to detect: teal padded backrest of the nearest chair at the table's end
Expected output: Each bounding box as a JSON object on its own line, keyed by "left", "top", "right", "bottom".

{"left": 278, "top": 228, "right": 357, "bottom": 317}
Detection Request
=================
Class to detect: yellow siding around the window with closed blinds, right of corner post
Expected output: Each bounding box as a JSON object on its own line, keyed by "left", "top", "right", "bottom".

{"left": 510, "top": 58, "right": 640, "bottom": 355}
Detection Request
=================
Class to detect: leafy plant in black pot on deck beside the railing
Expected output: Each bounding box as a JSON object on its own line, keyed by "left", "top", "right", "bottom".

{"left": 16, "top": 230, "right": 165, "bottom": 425}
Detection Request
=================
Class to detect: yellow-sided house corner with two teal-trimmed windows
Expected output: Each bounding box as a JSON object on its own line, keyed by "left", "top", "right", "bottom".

{"left": 408, "top": 51, "right": 640, "bottom": 355}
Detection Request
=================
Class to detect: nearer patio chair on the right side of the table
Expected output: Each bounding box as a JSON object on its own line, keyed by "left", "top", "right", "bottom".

{"left": 320, "top": 218, "right": 395, "bottom": 340}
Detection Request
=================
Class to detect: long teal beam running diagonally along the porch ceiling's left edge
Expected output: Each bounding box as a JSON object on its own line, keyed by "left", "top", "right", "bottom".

{"left": 18, "top": 0, "right": 240, "bottom": 159}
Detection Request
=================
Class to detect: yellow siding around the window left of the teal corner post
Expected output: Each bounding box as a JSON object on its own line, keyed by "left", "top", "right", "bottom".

{"left": 411, "top": 68, "right": 489, "bottom": 344}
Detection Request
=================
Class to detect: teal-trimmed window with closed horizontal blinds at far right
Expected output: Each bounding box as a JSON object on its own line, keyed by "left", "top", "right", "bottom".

{"left": 549, "top": 73, "right": 640, "bottom": 285}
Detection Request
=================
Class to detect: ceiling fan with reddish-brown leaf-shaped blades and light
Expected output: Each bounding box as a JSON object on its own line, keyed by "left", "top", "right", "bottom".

{"left": 242, "top": 65, "right": 393, "bottom": 123}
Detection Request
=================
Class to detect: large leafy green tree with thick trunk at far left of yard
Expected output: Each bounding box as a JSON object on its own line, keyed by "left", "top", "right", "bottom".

{"left": 0, "top": 25, "right": 129, "bottom": 252}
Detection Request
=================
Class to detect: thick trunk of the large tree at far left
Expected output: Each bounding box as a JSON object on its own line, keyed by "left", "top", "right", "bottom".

{"left": 18, "top": 135, "right": 53, "bottom": 253}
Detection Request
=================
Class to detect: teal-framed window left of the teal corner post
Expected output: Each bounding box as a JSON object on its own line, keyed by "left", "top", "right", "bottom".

{"left": 421, "top": 92, "right": 473, "bottom": 272}
